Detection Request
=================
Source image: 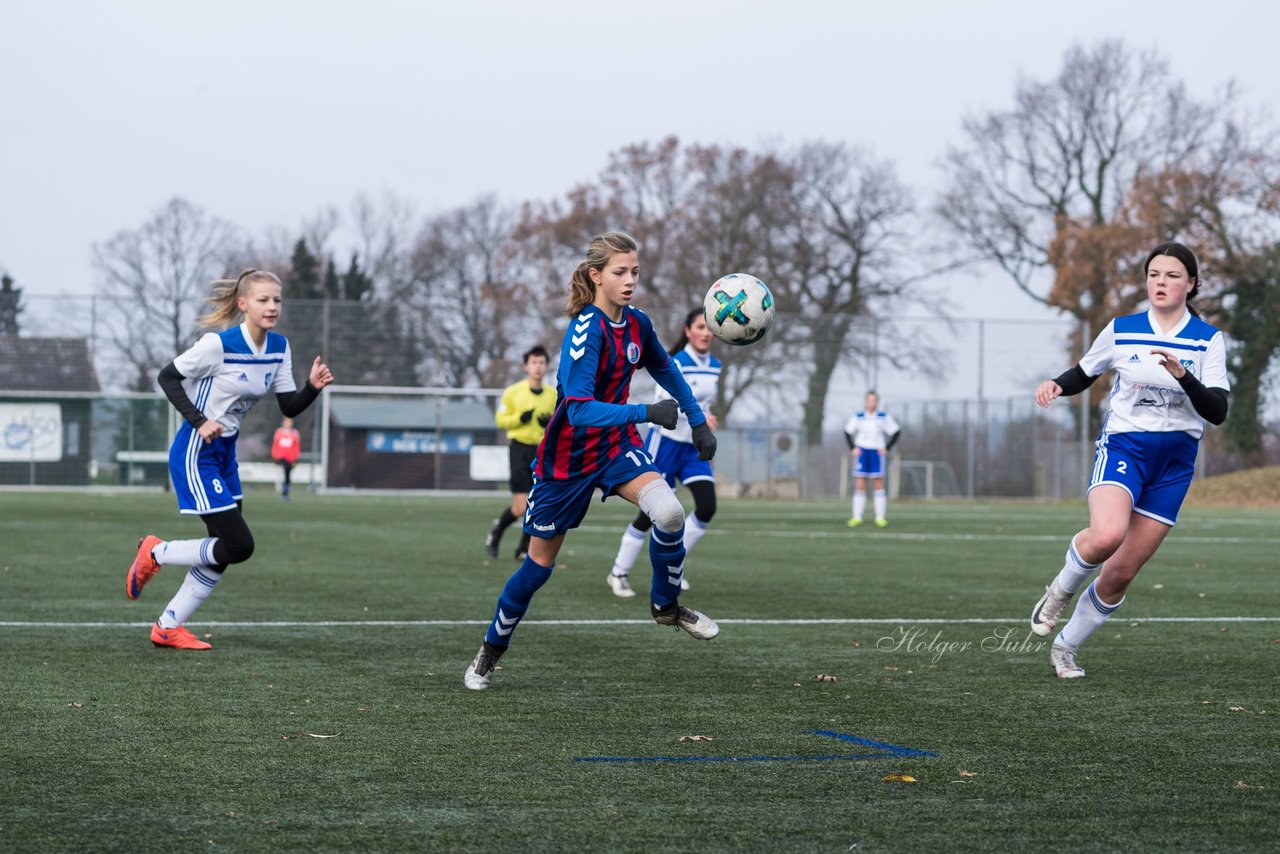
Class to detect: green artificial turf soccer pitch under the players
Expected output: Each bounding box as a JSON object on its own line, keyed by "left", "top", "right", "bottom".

{"left": 0, "top": 492, "right": 1280, "bottom": 851}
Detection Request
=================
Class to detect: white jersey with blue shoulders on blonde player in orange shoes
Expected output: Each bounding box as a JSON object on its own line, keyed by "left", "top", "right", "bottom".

{"left": 173, "top": 324, "right": 298, "bottom": 437}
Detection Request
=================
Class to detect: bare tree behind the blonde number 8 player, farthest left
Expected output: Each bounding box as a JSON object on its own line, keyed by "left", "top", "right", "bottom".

{"left": 92, "top": 197, "right": 237, "bottom": 389}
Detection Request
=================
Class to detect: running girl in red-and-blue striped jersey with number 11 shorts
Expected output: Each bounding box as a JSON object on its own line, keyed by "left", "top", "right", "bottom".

{"left": 463, "top": 232, "right": 719, "bottom": 690}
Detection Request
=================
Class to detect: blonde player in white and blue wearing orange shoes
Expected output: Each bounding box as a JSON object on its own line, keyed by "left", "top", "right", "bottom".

{"left": 125, "top": 270, "right": 333, "bottom": 649}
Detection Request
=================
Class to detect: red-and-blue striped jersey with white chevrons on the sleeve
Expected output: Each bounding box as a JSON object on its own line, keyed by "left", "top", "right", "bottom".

{"left": 534, "top": 305, "right": 680, "bottom": 480}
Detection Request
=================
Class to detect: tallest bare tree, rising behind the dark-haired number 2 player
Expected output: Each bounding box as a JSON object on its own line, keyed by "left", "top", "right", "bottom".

{"left": 937, "top": 41, "right": 1234, "bottom": 326}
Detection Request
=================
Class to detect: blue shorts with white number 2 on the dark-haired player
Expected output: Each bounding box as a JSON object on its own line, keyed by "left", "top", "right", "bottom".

{"left": 1089, "top": 431, "right": 1199, "bottom": 528}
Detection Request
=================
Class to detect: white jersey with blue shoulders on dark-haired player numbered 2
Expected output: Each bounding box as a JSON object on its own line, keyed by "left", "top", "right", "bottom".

{"left": 1080, "top": 311, "right": 1231, "bottom": 439}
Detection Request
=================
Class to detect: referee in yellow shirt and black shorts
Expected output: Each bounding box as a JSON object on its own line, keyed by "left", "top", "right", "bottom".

{"left": 484, "top": 344, "right": 556, "bottom": 561}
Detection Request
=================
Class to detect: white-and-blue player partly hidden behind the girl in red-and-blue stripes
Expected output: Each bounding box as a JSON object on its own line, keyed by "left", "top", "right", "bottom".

{"left": 608, "top": 307, "right": 721, "bottom": 598}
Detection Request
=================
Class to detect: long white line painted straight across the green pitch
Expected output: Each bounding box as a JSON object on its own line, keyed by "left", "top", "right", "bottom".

{"left": 0, "top": 615, "right": 1280, "bottom": 629}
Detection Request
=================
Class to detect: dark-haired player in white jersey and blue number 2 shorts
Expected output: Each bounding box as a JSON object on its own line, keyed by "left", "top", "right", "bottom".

{"left": 1032, "top": 243, "right": 1230, "bottom": 679}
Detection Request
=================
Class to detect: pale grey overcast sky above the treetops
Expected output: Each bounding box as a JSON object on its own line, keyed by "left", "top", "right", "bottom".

{"left": 0, "top": 0, "right": 1280, "bottom": 404}
